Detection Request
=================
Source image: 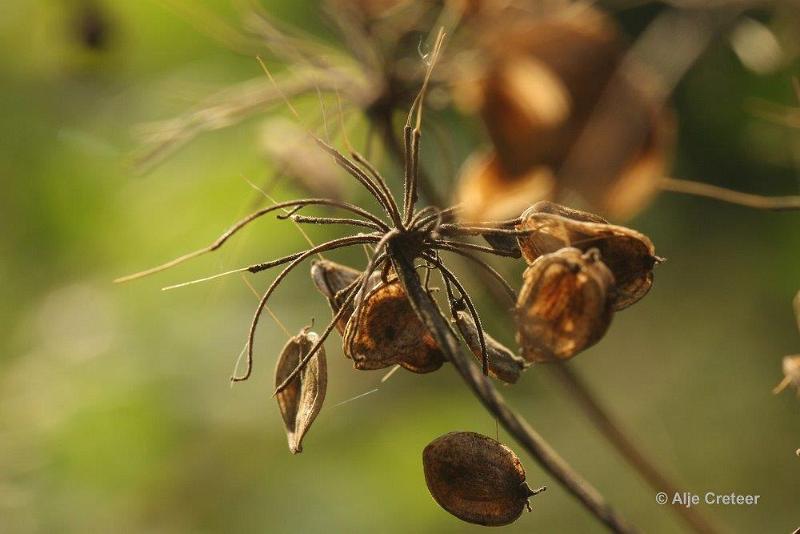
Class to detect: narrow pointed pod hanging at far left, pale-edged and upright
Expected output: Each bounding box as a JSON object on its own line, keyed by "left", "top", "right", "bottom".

{"left": 275, "top": 328, "right": 328, "bottom": 454}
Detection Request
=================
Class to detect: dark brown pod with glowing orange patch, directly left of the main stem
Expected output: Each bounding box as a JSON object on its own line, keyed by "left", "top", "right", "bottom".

{"left": 344, "top": 278, "right": 445, "bottom": 373}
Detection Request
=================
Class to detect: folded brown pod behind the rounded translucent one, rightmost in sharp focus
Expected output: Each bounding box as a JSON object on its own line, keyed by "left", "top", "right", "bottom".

{"left": 517, "top": 202, "right": 662, "bottom": 310}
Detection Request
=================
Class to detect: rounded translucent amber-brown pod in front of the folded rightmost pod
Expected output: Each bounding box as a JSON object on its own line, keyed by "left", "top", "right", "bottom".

{"left": 516, "top": 248, "right": 614, "bottom": 362}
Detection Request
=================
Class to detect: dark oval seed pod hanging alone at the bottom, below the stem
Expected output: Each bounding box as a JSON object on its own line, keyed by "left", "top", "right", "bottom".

{"left": 422, "top": 432, "right": 545, "bottom": 526}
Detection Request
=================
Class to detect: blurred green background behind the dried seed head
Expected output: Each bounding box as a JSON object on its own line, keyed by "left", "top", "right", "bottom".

{"left": 0, "top": 0, "right": 800, "bottom": 533}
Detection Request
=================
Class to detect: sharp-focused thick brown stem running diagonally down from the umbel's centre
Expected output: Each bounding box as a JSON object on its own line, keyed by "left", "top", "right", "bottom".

{"left": 389, "top": 246, "right": 636, "bottom": 533}
